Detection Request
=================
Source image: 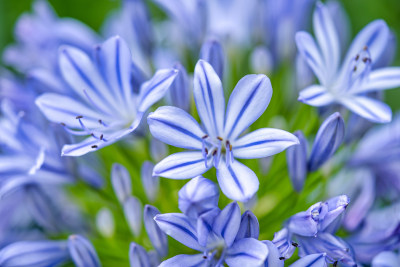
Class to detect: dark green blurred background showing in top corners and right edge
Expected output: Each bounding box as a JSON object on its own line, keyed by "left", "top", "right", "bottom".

{"left": 0, "top": 0, "right": 400, "bottom": 111}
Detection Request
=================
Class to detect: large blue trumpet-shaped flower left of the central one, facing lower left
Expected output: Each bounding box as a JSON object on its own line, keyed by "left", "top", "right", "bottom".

{"left": 36, "top": 37, "right": 177, "bottom": 156}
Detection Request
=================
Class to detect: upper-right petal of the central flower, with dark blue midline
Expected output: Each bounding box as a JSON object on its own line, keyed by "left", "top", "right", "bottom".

{"left": 224, "top": 74, "right": 272, "bottom": 140}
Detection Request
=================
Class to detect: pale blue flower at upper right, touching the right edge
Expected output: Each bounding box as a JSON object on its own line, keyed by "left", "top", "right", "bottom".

{"left": 296, "top": 3, "right": 400, "bottom": 123}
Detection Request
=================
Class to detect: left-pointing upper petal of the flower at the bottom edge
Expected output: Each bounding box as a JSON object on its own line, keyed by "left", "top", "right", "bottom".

{"left": 154, "top": 213, "right": 204, "bottom": 251}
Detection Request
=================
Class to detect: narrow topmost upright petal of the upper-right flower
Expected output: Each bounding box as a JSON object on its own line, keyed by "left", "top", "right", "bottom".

{"left": 313, "top": 2, "right": 341, "bottom": 84}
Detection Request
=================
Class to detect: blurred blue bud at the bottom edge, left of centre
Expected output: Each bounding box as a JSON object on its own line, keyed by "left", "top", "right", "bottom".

{"left": 68, "top": 235, "right": 101, "bottom": 267}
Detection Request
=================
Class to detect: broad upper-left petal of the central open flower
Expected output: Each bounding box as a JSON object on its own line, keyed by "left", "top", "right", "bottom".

{"left": 147, "top": 107, "right": 206, "bottom": 150}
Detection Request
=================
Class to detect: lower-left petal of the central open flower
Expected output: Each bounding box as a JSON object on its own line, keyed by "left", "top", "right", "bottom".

{"left": 153, "top": 151, "right": 212, "bottom": 179}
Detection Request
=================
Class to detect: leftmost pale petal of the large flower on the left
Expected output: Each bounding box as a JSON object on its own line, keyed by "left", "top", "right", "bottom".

{"left": 35, "top": 93, "right": 107, "bottom": 128}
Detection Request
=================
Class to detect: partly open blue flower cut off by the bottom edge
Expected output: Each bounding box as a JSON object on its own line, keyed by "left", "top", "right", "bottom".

{"left": 155, "top": 203, "right": 268, "bottom": 266}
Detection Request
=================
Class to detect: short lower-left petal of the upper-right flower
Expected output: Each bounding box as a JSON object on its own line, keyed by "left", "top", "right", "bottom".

{"left": 297, "top": 84, "right": 335, "bottom": 107}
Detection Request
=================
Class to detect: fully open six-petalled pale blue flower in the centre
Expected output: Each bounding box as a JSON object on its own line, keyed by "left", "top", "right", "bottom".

{"left": 147, "top": 60, "right": 298, "bottom": 201}
